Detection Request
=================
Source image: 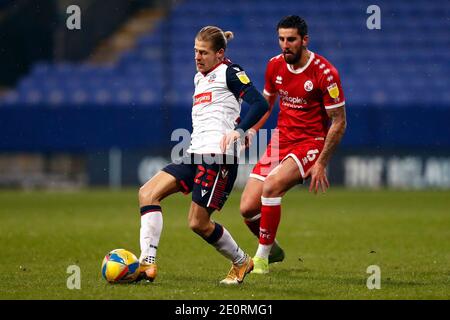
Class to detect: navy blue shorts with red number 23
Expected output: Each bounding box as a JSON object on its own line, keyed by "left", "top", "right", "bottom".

{"left": 162, "top": 154, "right": 238, "bottom": 210}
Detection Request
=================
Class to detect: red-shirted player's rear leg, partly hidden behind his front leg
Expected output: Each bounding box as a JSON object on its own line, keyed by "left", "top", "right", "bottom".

{"left": 240, "top": 175, "right": 285, "bottom": 263}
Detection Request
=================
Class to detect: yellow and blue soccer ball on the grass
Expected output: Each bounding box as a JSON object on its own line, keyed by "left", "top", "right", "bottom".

{"left": 102, "top": 249, "right": 139, "bottom": 283}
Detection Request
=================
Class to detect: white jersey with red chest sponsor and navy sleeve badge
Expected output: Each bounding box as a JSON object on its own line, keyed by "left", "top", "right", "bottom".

{"left": 187, "top": 61, "right": 250, "bottom": 156}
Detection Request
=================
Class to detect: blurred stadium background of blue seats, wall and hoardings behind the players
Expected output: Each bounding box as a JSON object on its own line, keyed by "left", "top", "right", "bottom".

{"left": 0, "top": 0, "right": 450, "bottom": 189}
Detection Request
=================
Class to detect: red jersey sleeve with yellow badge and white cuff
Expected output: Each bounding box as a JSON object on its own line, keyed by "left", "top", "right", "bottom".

{"left": 320, "top": 65, "right": 345, "bottom": 109}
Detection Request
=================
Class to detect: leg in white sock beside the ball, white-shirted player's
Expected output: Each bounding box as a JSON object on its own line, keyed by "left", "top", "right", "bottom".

{"left": 139, "top": 171, "right": 186, "bottom": 281}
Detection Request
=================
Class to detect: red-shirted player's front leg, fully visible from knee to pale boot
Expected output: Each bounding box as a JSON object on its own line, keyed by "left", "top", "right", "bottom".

{"left": 253, "top": 157, "right": 302, "bottom": 274}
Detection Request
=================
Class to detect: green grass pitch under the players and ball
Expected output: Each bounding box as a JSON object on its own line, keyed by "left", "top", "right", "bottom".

{"left": 0, "top": 188, "right": 450, "bottom": 300}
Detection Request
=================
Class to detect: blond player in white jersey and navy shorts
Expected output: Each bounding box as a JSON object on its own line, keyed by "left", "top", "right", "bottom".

{"left": 139, "top": 26, "right": 269, "bottom": 284}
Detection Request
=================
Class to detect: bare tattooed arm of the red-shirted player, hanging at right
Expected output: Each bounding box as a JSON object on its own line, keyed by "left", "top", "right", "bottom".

{"left": 305, "top": 106, "right": 347, "bottom": 193}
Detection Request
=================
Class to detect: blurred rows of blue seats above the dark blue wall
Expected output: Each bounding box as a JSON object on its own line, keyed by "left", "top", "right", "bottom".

{"left": 0, "top": 0, "right": 450, "bottom": 108}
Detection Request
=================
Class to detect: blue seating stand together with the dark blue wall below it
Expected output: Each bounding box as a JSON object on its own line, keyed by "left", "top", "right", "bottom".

{"left": 0, "top": 0, "right": 450, "bottom": 152}
